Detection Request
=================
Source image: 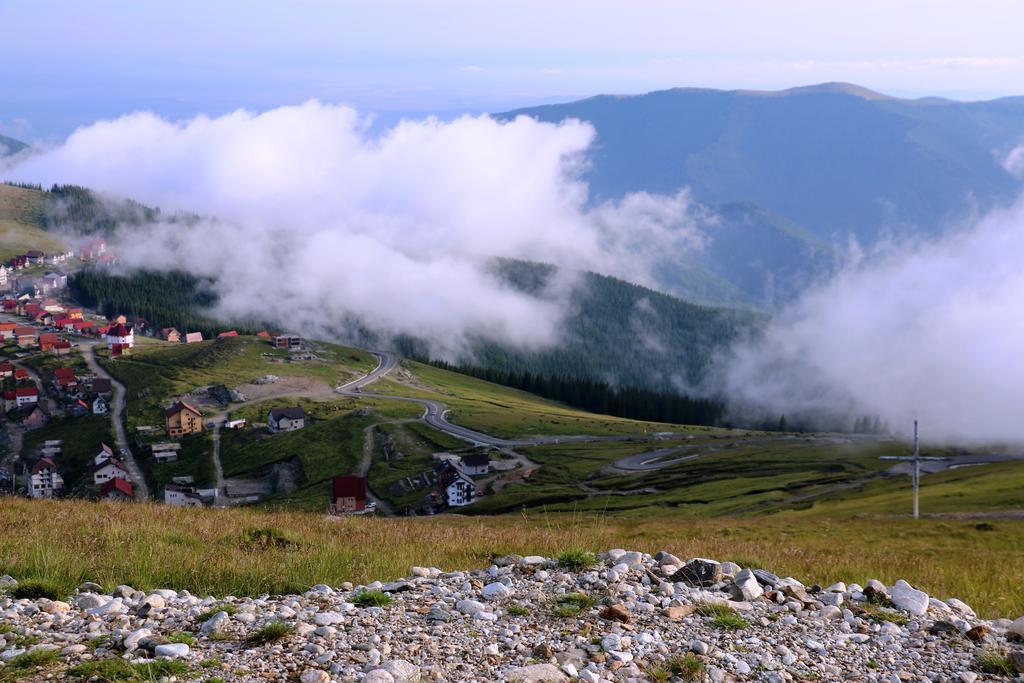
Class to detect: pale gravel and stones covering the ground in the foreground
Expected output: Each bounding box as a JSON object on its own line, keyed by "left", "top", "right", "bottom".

{"left": 0, "top": 550, "right": 1024, "bottom": 683}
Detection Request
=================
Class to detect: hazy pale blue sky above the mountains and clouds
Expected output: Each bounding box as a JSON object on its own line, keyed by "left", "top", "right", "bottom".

{"left": 0, "top": 0, "right": 1024, "bottom": 139}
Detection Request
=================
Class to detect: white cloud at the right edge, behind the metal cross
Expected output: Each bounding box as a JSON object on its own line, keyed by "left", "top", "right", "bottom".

{"left": 721, "top": 169, "right": 1024, "bottom": 441}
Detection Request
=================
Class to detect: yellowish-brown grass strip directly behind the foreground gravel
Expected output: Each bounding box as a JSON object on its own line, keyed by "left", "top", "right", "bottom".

{"left": 0, "top": 499, "right": 1024, "bottom": 617}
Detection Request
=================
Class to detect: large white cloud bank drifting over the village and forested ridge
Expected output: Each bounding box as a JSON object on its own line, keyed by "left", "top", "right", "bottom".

{"left": 4, "top": 101, "right": 697, "bottom": 352}
